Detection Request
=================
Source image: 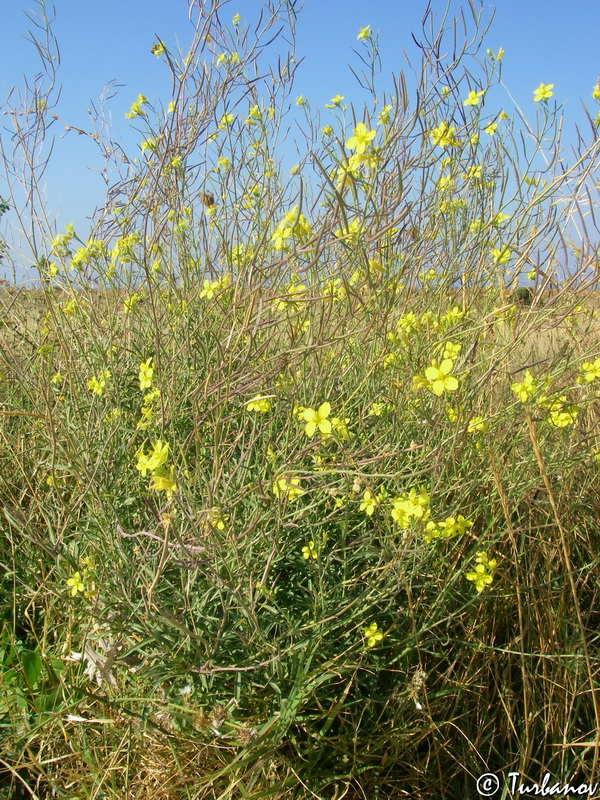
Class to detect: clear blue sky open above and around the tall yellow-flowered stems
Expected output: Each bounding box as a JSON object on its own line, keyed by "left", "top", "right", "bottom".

{"left": 0, "top": 0, "right": 600, "bottom": 284}
